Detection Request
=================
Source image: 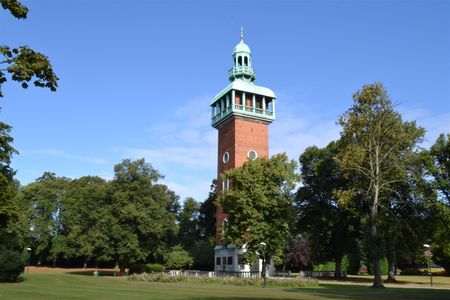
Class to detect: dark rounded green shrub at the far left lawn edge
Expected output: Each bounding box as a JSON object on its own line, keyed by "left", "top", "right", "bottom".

{"left": 0, "top": 248, "right": 25, "bottom": 282}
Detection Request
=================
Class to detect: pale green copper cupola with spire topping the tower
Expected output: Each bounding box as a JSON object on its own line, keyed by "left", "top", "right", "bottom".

{"left": 228, "top": 28, "right": 256, "bottom": 82}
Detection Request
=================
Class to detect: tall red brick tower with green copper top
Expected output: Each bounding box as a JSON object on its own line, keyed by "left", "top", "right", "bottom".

{"left": 211, "top": 30, "right": 275, "bottom": 272}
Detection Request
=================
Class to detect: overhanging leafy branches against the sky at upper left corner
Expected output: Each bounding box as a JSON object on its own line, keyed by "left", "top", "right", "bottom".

{"left": 0, "top": 0, "right": 59, "bottom": 97}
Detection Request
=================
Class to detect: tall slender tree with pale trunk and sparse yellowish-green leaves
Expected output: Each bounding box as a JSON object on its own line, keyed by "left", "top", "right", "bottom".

{"left": 338, "top": 83, "right": 424, "bottom": 287}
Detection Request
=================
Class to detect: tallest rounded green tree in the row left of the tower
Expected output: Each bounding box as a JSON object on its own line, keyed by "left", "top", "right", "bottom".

{"left": 110, "top": 159, "right": 178, "bottom": 272}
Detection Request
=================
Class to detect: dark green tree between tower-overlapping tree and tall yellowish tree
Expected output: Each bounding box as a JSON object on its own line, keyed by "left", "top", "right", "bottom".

{"left": 296, "top": 142, "right": 360, "bottom": 277}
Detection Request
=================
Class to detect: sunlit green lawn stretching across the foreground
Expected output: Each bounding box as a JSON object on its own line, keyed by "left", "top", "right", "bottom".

{"left": 0, "top": 273, "right": 450, "bottom": 300}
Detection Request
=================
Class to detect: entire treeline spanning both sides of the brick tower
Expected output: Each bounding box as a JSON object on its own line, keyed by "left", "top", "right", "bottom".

{"left": 0, "top": 83, "right": 450, "bottom": 286}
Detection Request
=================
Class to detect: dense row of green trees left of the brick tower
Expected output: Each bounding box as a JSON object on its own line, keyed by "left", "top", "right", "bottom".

{"left": 1, "top": 159, "right": 215, "bottom": 271}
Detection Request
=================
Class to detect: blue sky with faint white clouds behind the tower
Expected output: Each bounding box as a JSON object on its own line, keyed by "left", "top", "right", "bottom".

{"left": 0, "top": 0, "right": 450, "bottom": 200}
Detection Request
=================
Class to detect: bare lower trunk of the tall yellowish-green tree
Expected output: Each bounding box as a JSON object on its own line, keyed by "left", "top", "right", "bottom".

{"left": 370, "top": 183, "right": 384, "bottom": 288}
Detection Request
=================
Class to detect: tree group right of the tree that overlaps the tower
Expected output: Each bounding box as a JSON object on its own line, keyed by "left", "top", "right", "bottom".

{"left": 288, "top": 83, "right": 450, "bottom": 286}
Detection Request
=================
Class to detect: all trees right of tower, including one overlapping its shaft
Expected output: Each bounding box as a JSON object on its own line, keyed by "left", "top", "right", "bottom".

{"left": 219, "top": 83, "right": 450, "bottom": 287}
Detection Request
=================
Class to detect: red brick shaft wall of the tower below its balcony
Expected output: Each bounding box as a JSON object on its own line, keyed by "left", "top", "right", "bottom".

{"left": 216, "top": 117, "right": 269, "bottom": 245}
